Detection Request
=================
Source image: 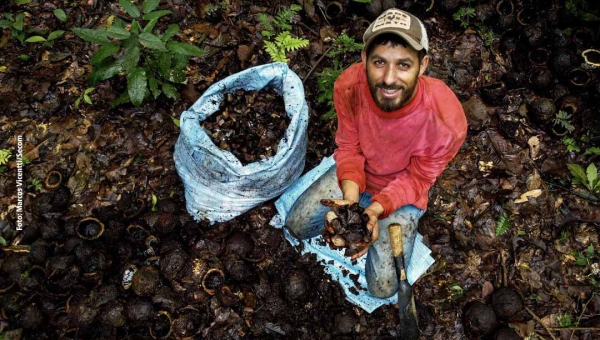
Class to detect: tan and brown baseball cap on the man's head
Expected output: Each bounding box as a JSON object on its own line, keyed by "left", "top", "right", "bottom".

{"left": 363, "top": 8, "right": 429, "bottom": 52}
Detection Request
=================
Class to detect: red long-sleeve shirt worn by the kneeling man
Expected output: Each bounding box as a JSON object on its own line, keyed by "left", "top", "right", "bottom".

{"left": 333, "top": 62, "right": 467, "bottom": 219}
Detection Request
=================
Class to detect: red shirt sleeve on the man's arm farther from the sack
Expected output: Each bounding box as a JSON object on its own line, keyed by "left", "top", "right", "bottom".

{"left": 371, "top": 127, "right": 466, "bottom": 219}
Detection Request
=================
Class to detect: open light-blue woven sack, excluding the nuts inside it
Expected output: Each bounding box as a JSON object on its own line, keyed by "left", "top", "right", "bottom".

{"left": 173, "top": 63, "right": 308, "bottom": 223}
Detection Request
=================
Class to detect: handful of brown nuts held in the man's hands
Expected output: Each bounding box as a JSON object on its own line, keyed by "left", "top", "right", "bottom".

{"left": 321, "top": 199, "right": 371, "bottom": 256}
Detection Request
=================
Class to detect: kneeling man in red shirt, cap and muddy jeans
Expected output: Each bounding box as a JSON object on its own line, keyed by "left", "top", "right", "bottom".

{"left": 285, "top": 9, "right": 467, "bottom": 298}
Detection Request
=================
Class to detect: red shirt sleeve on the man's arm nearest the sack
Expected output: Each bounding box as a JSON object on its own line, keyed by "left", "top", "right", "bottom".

{"left": 333, "top": 81, "right": 366, "bottom": 193}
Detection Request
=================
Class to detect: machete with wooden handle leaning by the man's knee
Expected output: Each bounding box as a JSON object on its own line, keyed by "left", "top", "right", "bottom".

{"left": 389, "top": 223, "right": 420, "bottom": 340}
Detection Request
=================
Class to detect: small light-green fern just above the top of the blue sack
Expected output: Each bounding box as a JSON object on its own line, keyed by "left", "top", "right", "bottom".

{"left": 258, "top": 4, "right": 309, "bottom": 63}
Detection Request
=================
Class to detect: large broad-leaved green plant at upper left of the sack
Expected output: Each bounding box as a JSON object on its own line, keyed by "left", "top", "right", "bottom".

{"left": 73, "top": 0, "right": 204, "bottom": 107}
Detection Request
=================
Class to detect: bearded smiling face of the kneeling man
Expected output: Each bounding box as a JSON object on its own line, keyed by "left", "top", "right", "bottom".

{"left": 362, "top": 42, "right": 429, "bottom": 112}
